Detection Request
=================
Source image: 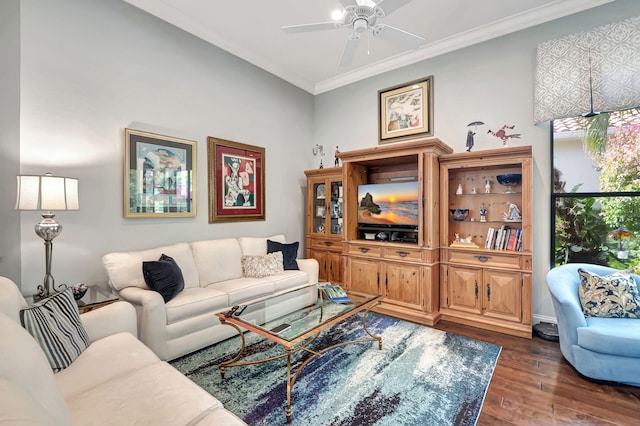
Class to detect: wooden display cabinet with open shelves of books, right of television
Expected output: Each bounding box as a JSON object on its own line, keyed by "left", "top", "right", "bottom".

{"left": 440, "top": 146, "right": 533, "bottom": 338}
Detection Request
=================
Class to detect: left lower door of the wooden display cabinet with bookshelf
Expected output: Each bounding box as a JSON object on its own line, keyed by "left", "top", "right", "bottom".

{"left": 447, "top": 266, "right": 482, "bottom": 315}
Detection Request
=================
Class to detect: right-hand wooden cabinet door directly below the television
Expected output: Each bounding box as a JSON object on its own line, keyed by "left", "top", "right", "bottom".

{"left": 383, "top": 263, "right": 422, "bottom": 308}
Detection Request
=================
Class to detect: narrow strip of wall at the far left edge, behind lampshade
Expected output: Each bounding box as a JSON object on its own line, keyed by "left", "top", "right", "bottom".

{"left": 0, "top": 0, "right": 21, "bottom": 282}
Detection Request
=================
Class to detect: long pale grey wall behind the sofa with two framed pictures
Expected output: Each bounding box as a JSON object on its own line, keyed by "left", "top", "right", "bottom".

{"left": 13, "top": 0, "right": 313, "bottom": 293}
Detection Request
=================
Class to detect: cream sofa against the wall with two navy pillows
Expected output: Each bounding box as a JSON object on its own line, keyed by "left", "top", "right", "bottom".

{"left": 102, "top": 235, "right": 318, "bottom": 360}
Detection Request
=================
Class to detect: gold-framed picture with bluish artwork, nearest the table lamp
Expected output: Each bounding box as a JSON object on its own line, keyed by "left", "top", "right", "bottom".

{"left": 123, "top": 129, "right": 197, "bottom": 218}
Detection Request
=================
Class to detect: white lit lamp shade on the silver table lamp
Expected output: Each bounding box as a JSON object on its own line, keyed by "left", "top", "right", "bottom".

{"left": 16, "top": 173, "right": 80, "bottom": 211}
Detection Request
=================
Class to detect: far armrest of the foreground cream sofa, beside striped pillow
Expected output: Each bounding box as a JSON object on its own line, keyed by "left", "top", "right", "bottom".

{"left": 80, "top": 302, "right": 138, "bottom": 342}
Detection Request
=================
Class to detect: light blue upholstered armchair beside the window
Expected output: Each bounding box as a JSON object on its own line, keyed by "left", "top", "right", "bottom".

{"left": 547, "top": 263, "right": 640, "bottom": 386}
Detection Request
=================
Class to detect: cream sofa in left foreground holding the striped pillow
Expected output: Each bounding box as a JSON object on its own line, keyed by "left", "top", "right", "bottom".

{"left": 0, "top": 277, "right": 245, "bottom": 426}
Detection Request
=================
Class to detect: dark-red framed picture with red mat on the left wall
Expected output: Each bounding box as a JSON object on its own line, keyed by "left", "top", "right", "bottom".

{"left": 207, "top": 136, "right": 266, "bottom": 223}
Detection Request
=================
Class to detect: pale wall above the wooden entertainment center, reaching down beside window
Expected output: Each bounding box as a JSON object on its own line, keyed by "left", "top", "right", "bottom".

{"left": 315, "top": 0, "right": 640, "bottom": 322}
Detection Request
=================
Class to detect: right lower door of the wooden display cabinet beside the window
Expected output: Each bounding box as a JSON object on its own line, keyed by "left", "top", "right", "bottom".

{"left": 483, "top": 270, "right": 522, "bottom": 322}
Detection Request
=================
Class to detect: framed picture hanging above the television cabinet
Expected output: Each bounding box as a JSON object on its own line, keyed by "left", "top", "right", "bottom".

{"left": 378, "top": 76, "right": 433, "bottom": 144}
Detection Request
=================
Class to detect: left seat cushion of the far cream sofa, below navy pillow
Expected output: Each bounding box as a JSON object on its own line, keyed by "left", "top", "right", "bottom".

{"left": 166, "top": 287, "right": 229, "bottom": 324}
